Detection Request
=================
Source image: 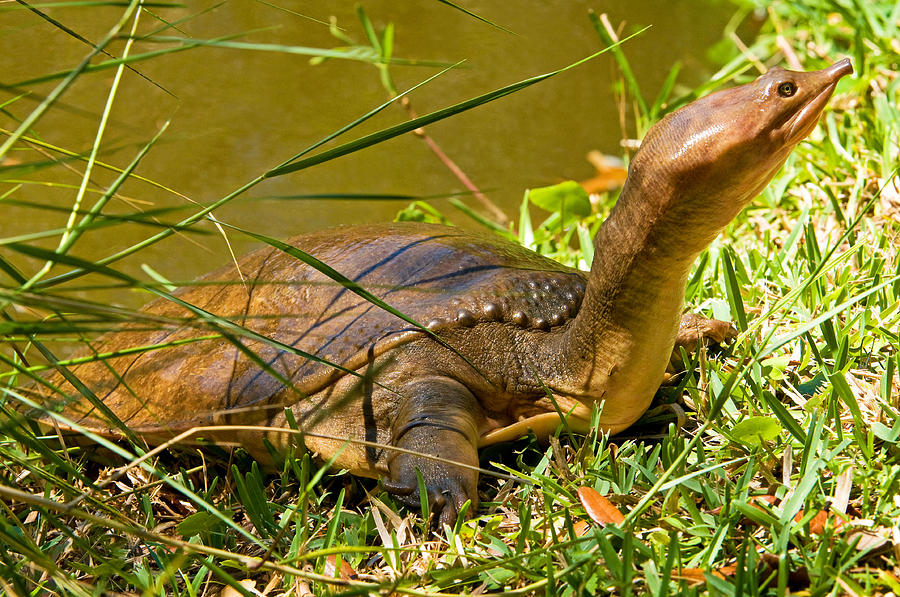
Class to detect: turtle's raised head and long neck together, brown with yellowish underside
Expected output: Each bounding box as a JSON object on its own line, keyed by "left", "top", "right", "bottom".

{"left": 541, "top": 59, "right": 852, "bottom": 433}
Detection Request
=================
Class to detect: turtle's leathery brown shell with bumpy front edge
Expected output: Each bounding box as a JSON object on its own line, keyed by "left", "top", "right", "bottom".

{"left": 42, "top": 223, "right": 586, "bottom": 432}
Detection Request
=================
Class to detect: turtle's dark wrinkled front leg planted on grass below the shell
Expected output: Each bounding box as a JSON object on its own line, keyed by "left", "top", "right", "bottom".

{"left": 382, "top": 377, "right": 482, "bottom": 524}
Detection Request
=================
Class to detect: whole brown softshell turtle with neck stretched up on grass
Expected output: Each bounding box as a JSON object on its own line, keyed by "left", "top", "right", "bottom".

{"left": 33, "top": 59, "right": 852, "bottom": 521}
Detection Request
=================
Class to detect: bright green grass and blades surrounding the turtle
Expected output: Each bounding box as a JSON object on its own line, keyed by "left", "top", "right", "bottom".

{"left": 0, "top": 0, "right": 900, "bottom": 596}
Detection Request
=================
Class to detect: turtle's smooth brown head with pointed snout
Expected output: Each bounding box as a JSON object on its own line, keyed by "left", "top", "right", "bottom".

{"left": 629, "top": 58, "right": 853, "bottom": 235}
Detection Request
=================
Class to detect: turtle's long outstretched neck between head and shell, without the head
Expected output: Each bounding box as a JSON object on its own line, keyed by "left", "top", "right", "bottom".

{"left": 536, "top": 175, "right": 721, "bottom": 425}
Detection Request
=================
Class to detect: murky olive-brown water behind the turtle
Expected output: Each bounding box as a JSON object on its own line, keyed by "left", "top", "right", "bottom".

{"left": 0, "top": 0, "right": 733, "bottom": 304}
